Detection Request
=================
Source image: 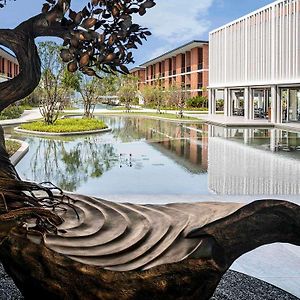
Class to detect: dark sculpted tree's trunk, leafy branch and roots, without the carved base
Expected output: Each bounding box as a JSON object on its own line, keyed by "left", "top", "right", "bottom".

{"left": 0, "top": 0, "right": 155, "bottom": 247}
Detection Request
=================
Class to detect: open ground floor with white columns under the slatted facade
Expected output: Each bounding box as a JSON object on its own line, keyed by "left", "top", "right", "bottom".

{"left": 209, "top": 84, "right": 300, "bottom": 124}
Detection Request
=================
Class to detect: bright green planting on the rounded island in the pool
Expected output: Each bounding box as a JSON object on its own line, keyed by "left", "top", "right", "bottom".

{"left": 20, "top": 119, "right": 107, "bottom": 133}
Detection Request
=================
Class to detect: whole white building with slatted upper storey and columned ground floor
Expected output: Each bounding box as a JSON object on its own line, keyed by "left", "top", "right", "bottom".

{"left": 209, "top": 0, "right": 300, "bottom": 123}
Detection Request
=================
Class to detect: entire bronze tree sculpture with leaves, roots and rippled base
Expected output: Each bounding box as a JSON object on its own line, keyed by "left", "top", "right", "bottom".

{"left": 0, "top": 0, "right": 300, "bottom": 300}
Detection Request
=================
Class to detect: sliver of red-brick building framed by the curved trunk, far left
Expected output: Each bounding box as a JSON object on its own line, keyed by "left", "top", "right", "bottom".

{"left": 0, "top": 48, "right": 19, "bottom": 82}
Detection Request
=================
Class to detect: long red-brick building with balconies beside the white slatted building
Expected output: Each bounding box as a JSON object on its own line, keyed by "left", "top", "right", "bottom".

{"left": 131, "top": 41, "right": 209, "bottom": 96}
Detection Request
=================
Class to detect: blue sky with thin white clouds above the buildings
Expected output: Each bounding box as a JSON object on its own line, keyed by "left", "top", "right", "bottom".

{"left": 0, "top": 0, "right": 272, "bottom": 68}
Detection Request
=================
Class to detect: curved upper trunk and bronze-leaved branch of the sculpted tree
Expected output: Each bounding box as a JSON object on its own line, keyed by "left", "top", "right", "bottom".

{"left": 0, "top": 0, "right": 155, "bottom": 111}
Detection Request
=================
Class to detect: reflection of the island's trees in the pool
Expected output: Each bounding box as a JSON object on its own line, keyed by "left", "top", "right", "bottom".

{"left": 31, "top": 136, "right": 118, "bottom": 191}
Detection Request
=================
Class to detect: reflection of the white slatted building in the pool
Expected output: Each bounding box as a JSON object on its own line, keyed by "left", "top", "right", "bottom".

{"left": 208, "top": 127, "right": 300, "bottom": 195}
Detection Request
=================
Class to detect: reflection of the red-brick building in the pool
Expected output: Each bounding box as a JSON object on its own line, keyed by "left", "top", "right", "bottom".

{"left": 110, "top": 117, "right": 208, "bottom": 173}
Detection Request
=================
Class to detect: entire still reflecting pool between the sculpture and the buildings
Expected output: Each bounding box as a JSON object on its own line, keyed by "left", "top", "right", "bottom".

{"left": 6, "top": 117, "right": 300, "bottom": 196}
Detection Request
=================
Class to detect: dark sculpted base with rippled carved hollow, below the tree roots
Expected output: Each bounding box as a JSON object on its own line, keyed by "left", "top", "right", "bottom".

{"left": 0, "top": 195, "right": 300, "bottom": 300}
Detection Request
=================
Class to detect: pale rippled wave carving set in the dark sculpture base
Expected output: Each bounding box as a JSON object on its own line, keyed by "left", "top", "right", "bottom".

{"left": 44, "top": 195, "right": 243, "bottom": 271}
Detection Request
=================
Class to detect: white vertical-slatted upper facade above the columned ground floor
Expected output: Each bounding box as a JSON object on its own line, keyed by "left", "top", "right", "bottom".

{"left": 209, "top": 0, "right": 300, "bottom": 88}
